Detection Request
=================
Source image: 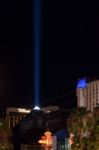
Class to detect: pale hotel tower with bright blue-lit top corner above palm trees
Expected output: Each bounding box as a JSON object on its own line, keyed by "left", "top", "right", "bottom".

{"left": 76, "top": 79, "right": 99, "bottom": 111}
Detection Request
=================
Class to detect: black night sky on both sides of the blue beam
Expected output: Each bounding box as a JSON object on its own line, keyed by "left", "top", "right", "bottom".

{"left": 0, "top": 0, "right": 99, "bottom": 108}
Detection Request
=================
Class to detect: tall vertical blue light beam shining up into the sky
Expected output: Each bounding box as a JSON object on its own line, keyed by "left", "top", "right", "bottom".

{"left": 33, "top": 0, "right": 41, "bottom": 106}
